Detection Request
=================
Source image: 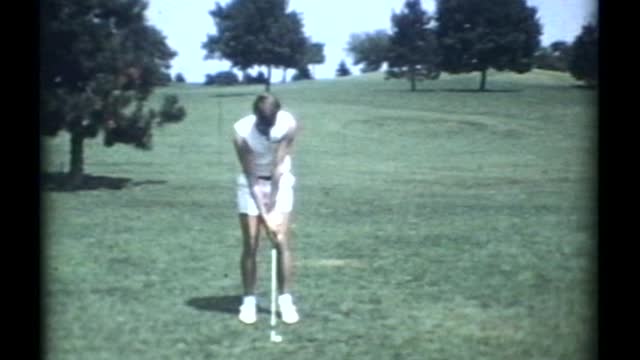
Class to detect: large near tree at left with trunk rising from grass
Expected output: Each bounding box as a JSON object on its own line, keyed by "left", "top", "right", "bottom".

{"left": 40, "top": 0, "right": 185, "bottom": 188}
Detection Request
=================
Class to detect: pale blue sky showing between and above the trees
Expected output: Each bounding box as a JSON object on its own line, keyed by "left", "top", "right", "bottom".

{"left": 147, "top": 0, "right": 597, "bottom": 82}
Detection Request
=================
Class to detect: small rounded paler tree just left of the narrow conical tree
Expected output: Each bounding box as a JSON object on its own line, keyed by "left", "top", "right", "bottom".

{"left": 345, "top": 30, "right": 389, "bottom": 73}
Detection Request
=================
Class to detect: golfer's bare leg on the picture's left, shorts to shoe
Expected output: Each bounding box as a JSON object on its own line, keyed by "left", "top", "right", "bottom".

{"left": 240, "top": 214, "right": 260, "bottom": 296}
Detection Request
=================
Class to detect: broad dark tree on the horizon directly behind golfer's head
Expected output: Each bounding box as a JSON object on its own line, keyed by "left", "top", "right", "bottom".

{"left": 202, "top": 0, "right": 307, "bottom": 91}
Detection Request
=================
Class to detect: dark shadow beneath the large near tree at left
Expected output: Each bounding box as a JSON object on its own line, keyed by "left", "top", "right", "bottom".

{"left": 40, "top": 172, "right": 167, "bottom": 192}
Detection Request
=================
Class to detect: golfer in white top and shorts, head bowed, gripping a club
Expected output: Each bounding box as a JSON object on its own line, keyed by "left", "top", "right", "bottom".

{"left": 233, "top": 93, "right": 299, "bottom": 324}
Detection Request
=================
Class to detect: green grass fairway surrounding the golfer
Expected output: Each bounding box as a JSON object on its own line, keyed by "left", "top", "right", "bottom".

{"left": 43, "top": 71, "right": 597, "bottom": 360}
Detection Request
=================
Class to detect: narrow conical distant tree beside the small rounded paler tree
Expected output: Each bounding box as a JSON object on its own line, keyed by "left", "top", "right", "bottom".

{"left": 387, "top": 0, "right": 440, "bottom": 91}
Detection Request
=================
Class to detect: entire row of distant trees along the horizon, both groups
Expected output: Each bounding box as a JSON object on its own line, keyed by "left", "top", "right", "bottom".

{"left": 202, "top": 0, "right": 597, "bottom": 91}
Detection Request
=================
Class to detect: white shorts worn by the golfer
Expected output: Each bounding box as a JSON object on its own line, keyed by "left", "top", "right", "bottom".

{"left": 236, "top": 173, "right": 296, "bottom": 216}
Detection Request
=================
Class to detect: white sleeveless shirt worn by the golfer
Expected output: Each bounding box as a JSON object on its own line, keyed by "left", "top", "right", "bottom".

{"left": 233, "top": 110, "right": 296, "bottom": 176}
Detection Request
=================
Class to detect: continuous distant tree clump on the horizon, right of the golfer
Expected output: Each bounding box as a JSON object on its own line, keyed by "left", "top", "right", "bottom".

{"left": 346, "top": 0, "right": 598, "bottom": 90}
